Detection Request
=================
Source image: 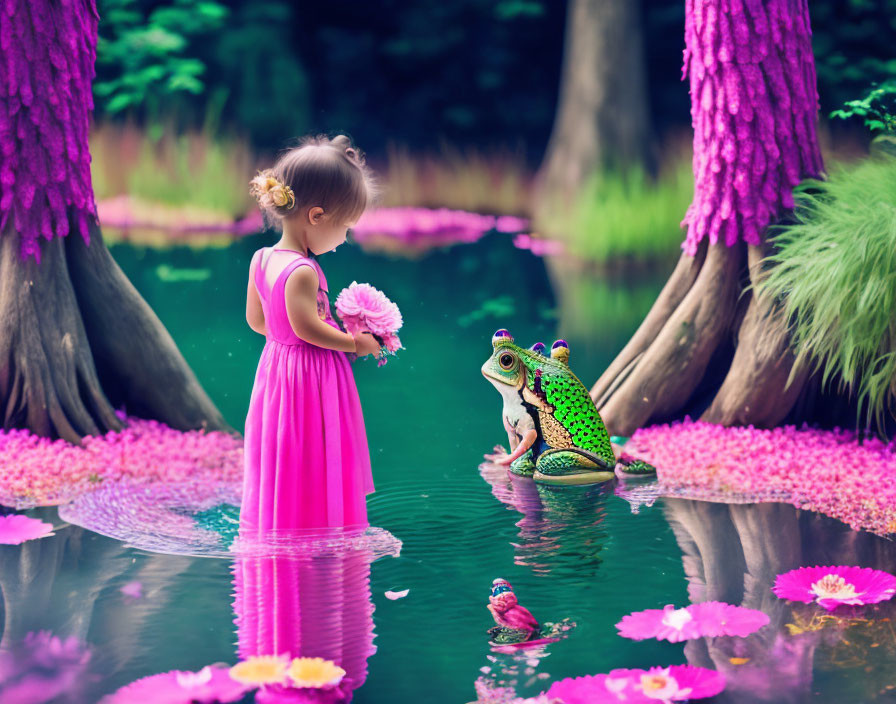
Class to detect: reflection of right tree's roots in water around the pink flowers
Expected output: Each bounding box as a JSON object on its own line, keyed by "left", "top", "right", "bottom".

{"left": 664, "top": 499, "right": 896, "bottom": 704}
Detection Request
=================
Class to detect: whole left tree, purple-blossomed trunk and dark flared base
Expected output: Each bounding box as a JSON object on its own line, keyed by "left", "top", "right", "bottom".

{"left": 0, "top": 0, "right": 229, "bottom": 444}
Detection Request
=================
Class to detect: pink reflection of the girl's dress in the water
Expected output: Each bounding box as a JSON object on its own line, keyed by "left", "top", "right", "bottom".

{"left": 233, "top": 542, "right": 376, "bottom": 704}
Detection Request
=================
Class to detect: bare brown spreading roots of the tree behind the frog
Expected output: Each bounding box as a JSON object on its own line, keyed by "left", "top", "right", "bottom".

{"left": 591, "top": 239, "right": 809, "bottom": 435}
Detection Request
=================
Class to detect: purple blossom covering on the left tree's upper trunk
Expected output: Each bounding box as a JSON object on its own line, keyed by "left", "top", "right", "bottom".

{"left": 0, "top": 0, "right": 99, "bottom": 263}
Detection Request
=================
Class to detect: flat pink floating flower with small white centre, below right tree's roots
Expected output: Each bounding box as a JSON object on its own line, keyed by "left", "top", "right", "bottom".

{"left": 616, "top": 601, "right": 769, "bottom": 643}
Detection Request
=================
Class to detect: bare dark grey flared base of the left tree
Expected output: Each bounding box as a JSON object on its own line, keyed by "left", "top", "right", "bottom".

{"left": 0, "top": 216, "right": 232, "bottom": 445}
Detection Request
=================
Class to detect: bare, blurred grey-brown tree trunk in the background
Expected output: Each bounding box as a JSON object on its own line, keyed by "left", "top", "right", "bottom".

{"left": 538, "top": 0, "right": 649, "bottom": 218}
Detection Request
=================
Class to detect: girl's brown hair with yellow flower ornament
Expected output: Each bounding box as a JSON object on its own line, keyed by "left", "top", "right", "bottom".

{"left": 249, "top": 134, "right": 378, "bottom": 229}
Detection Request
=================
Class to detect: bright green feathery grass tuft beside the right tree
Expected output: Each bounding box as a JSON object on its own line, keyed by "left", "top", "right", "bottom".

{"left": 757, "top": 156, "right": 896, "bottom": 429}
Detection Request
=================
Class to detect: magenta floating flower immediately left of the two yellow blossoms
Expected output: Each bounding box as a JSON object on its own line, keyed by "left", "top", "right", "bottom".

{"left": 100, "top": 665, "right": 251, "bottom": 704}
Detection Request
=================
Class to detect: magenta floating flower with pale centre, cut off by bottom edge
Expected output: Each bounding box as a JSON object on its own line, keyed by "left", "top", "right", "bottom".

{"left": 547, "top": 665, "right": 725, "bottom": 704}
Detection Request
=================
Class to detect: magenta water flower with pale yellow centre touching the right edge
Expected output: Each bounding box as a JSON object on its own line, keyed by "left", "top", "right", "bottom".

{"left": 772, "top": 566, "right": 896, "bottom": 611}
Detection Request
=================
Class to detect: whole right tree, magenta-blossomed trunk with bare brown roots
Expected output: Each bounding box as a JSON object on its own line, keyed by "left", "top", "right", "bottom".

{"left": 591, "top": 0, "right": 823, "bottom": 435}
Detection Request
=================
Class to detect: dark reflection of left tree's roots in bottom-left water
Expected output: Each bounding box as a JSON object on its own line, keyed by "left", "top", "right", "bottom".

{"left": 0, "top": 509, "right": 189, "bottom": 704}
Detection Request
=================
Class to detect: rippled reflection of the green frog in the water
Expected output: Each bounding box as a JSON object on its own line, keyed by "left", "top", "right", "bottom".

{"left": 479, "top": 463, "right": 613, "bottom": 582}
